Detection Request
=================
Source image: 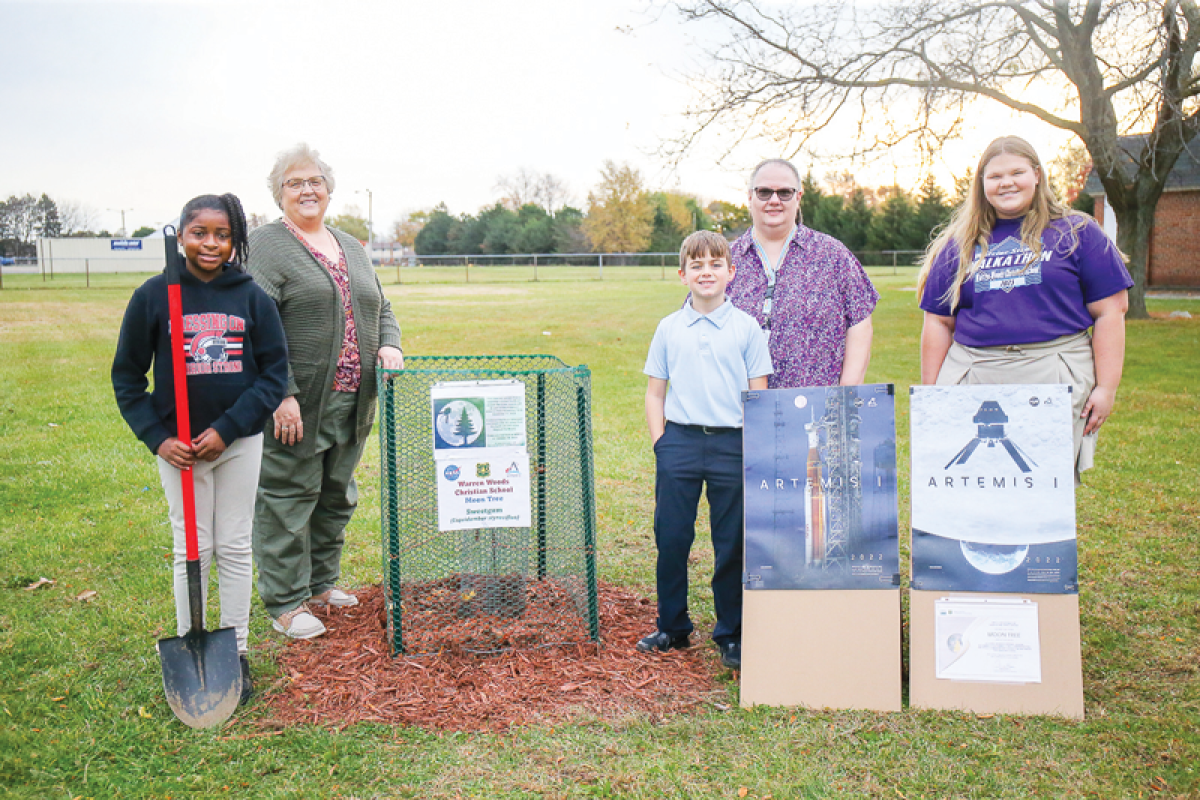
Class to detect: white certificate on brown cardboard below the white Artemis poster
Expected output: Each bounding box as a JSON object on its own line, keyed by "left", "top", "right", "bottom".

{"left": 934, "top": 597, "right": 1042, "bottom": 684}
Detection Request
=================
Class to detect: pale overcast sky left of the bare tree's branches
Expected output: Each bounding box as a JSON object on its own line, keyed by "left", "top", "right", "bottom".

{"left": 0, "top": 0, "right": 1070, "bottom": 231}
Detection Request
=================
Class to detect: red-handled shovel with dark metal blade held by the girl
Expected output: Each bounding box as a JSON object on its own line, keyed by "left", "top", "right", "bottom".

{"left": 158, "top": 225, "right": 241, "bottom": 728}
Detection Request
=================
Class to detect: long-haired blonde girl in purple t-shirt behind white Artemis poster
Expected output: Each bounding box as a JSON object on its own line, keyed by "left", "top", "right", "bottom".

{"left": 917, "top": 137, "right": 1133, "bottom": 477}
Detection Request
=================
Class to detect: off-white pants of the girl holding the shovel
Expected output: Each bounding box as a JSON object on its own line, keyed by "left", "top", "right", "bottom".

{"left": 158, "top": 433, "right": 263, "bottom": 652}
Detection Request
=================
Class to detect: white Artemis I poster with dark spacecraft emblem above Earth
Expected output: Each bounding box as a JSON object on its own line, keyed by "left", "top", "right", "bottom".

{"left": 910, "top": 385, "right": 1079, "bottom": 594}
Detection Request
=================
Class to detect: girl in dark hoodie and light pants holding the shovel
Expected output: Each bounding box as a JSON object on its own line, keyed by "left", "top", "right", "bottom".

{"left": 113, "top": 194, "right": 288, "bottom": 702}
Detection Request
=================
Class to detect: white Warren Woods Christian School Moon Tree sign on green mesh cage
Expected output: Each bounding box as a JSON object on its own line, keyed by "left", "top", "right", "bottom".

{"left": 436, "top": 450, "right": 530, "bottom": 530}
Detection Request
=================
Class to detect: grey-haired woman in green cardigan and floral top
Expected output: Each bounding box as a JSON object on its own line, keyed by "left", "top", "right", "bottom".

{"left": 246, "top": 144, "right": 404, "bottom": 639}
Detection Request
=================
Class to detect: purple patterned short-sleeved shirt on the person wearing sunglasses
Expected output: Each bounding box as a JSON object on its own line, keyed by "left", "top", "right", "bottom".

{"left": 726, "top": 224, "right": 880, "bottom": 389}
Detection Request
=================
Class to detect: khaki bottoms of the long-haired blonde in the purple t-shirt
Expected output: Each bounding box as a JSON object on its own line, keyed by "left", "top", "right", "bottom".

{"left": 937, "top": 331, "right": 1097, "bottom": 474}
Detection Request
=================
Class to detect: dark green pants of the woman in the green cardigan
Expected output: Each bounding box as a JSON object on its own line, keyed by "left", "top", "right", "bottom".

{"left": 254, "top": 392, "right": 366, "bottom": 616}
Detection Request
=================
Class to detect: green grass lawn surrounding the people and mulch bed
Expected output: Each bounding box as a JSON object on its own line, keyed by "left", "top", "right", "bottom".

{"left": 0, "top": 273, "right": 1200, "bottom": 799}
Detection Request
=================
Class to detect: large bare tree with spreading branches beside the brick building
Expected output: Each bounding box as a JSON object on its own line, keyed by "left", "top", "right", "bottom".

{"left": 676, "top": 0, "right": 1200, "bottom": 317}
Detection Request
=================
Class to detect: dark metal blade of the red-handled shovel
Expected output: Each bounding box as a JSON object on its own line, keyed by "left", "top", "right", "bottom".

{"left": 158, "top": 627, "right": 241, "bottom": 728}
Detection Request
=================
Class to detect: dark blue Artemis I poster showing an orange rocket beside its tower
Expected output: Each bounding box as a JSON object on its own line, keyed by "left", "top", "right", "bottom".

{"left": 743, "top": 384, "right": 900, "bottom": 589}
